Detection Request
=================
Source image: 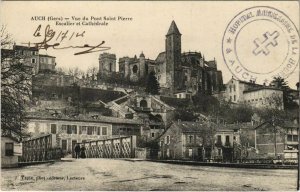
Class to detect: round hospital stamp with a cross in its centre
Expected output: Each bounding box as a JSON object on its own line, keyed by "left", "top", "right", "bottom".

{"left": 222, "top": 6, "right": 299, "bottom": 83}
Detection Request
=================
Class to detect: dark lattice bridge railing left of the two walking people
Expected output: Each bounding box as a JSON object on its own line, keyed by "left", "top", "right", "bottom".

{"left": 20, "top": 134, "right": 62, "bottom": 162}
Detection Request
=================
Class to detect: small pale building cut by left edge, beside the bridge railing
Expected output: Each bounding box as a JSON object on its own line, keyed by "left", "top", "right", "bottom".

{"left": 1, "top": 136, "right": 22, "bottom": 168}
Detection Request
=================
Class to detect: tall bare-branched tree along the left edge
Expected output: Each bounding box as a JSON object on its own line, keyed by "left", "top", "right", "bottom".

{"left": 1, "top": 26, "right": 33, "bottom": 139}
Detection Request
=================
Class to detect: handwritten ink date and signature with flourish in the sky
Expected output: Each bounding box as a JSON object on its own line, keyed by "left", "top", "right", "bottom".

{"left": 27, "top": 25, "right": 110, "bottom": 55}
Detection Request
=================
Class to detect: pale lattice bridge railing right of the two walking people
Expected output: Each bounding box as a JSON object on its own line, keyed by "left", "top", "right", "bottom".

{"left": 83, "top": 136, "right": 136, "bottom": 158}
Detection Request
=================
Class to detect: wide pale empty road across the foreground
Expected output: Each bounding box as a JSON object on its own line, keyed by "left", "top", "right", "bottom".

{"left": 1, "top": 159, "right": 297, "bottom": 191}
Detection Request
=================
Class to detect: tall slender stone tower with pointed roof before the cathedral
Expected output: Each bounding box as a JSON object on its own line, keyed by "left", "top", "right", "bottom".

{"left": 166, "top": 21, "right": 181, "bottom": 92}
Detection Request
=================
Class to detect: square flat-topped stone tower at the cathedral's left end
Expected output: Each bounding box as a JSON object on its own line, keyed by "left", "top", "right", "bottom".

{"left": 99, "top": 53, "right": 117, "bottom": 76}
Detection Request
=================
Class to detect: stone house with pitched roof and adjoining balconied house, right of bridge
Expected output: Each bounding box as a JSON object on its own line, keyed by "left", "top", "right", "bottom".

{"left": 159, "top": 121, "right": 239, "bottom": 161}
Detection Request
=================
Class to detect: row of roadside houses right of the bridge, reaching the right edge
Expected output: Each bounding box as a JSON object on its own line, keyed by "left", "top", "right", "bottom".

{"left": 158, "top": 121, "right": 299, "bottom": 163}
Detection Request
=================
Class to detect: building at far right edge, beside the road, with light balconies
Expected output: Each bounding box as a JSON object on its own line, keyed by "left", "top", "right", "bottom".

{"left": 255, "top": 121, "right": 299, "bottom": 159}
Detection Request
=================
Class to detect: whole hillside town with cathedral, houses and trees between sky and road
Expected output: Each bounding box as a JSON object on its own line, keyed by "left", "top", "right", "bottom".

{"left": 1, "top": 21, "right": 299, "bottom": 167}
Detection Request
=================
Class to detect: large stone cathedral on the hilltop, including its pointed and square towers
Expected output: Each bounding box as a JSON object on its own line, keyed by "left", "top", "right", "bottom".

{"left": 99, "top": 21, "right": 223, "bottom": 95}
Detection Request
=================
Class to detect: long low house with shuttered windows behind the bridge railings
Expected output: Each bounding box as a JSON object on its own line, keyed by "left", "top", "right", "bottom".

{"left": 26, "top": 111, "right": 142, "bottom": 152}
